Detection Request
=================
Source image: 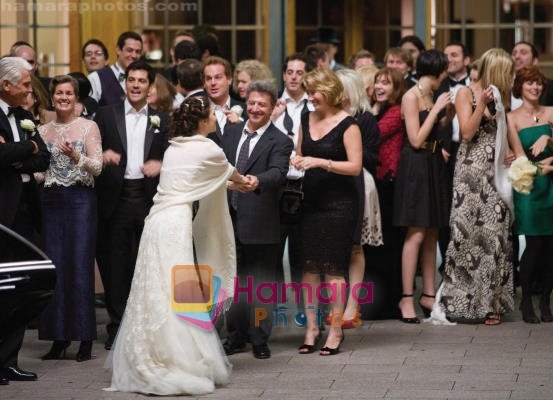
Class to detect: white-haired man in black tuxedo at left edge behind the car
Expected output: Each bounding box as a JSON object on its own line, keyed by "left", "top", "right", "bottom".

{"left": 0, "top": 57, "right": 50, "bottom": 385}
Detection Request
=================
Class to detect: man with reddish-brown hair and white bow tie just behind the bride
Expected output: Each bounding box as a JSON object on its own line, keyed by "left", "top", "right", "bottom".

{"left": 202, "top": 56, "right": 244, "bottom": 145}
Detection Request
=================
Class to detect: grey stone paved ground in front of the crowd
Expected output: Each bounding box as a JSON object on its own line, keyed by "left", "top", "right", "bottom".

{"left": 0, "top": 296, "right": 553, "bottom": 400}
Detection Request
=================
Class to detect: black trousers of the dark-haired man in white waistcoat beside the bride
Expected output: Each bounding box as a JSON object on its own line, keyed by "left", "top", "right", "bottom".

{"left": 96, "top": 180, "right": 148, "bottom": 338}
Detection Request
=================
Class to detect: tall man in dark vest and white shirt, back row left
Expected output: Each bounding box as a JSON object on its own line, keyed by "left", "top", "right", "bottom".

{"left": 88, "top": 32, "right": 142, "bottom": 106}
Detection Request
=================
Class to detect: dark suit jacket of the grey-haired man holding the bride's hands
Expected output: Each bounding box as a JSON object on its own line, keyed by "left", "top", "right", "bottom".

{"left": 222, "top": 122, "right": 294, "bottom": 244}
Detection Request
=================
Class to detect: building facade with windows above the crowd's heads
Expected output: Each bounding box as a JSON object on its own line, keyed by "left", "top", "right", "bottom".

{"left": 0, "top": 0, "right": 553, "bottom": 77}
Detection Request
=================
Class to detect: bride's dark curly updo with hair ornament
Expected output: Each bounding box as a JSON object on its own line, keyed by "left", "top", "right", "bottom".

{"left": 171, "top": 96, "right": 211, "bottom": 137}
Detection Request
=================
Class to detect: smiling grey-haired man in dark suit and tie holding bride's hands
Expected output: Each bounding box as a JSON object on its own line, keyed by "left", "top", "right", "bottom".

{"left": 222, "top": 81, "right": 293, "bottom": 359}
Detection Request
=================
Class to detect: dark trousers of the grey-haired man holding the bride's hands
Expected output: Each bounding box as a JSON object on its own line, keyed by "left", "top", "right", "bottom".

{"left": 227, "top": 240, "right": 280, "bottom": 346}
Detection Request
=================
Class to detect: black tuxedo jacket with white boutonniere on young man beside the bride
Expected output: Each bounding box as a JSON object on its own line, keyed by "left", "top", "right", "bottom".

{"left": 94, "top": 102, "right": 169, "bottom": 219}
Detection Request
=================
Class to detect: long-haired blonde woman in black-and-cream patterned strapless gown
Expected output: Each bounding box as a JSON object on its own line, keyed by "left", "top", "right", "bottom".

{"left": 439, "top": 49, "right": 514, "bottom": 325}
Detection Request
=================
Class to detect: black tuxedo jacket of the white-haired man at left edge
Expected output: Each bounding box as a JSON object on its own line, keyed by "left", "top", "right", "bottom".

{"left": 0, "top": 108, "right": 50, "bottom": 227}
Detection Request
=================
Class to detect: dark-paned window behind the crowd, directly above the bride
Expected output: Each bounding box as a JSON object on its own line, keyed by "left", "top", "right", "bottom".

{"left": 136, "top": 0, "right": 264, "bottom": 63}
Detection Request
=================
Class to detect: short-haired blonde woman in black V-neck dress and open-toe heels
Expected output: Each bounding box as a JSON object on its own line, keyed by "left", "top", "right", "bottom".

{"left": 291, "top": 69, "right": 362, "bottom": 356}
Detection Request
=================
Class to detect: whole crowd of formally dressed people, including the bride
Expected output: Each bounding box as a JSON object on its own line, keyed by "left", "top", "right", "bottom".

{"left": 0, "top": 28, "right": 553, "bottom": 395}
